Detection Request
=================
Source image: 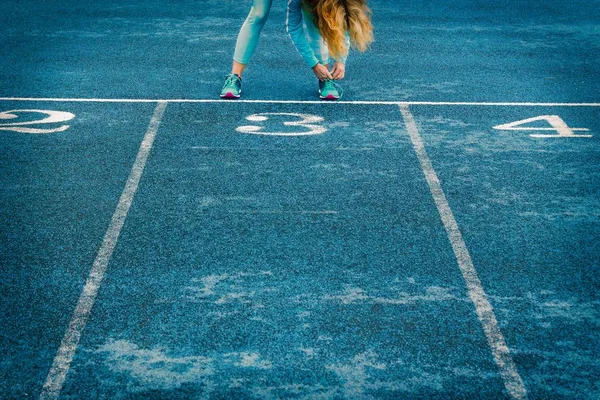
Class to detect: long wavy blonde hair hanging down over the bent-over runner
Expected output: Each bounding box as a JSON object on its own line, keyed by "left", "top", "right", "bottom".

{"left": 303, "top": 0, "right": 373, "bottom": 59}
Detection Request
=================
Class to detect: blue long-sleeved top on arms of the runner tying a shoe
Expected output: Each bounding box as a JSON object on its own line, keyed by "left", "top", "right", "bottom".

{"left": 286, "top": 0, "right": 350, "bottom": 68}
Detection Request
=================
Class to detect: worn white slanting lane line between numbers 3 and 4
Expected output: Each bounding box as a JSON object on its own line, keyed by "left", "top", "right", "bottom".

{"left": 400, "top": 105, "right": 527, "bottom": 399}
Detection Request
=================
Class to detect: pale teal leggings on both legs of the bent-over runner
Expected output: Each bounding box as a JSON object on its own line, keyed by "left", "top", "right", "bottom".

{"left": 233, "top": 0, "right": 329, "bottom": 65}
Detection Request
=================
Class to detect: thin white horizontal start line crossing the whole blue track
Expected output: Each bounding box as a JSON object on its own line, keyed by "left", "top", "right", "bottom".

{"left": 0, "top": 97, "right": 600, "bottom": 107}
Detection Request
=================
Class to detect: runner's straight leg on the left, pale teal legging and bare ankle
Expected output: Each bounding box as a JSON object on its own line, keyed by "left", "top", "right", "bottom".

{"left": 231, "top": 0, "right": 273, "bottom": 76}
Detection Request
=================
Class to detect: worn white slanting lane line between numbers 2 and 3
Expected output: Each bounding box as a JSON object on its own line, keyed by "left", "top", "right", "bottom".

{"left": 40, "top": 102, "right": 167, "bottom": 400}
